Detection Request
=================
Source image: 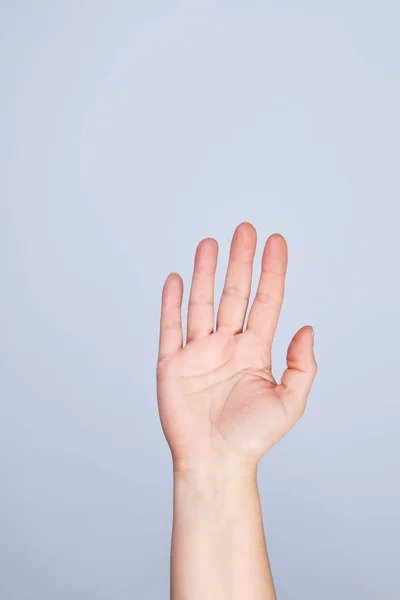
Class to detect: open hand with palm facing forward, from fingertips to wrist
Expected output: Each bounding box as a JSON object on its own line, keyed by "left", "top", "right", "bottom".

{"left": 157, "top": 223, "right": 317, "bottom": 470}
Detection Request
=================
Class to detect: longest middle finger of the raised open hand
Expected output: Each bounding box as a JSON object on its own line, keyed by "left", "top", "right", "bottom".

{"left": 217, "top": 223, "right": 257, "bottom": 333}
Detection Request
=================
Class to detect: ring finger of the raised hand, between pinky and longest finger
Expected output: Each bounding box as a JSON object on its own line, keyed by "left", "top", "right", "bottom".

{"left": 187, "top": 238, "right": 218, "bottom": 342}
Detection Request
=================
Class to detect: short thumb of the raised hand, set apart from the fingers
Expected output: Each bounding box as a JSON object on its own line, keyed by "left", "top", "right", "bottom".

{"left": 277, "top": 325, "right": 317, "bottom": 421}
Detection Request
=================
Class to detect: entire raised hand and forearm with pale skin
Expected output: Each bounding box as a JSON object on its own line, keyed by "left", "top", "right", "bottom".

{"left": 157, "top": 223, "right": 317, "bottom": 600}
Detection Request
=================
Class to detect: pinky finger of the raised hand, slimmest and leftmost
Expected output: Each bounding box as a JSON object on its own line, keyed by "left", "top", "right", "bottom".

{"left": 159, "top": 273, "right": 183, "bottom": 359}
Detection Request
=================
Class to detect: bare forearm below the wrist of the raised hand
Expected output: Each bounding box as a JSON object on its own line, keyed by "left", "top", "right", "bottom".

{"left": 171, "top": 467, "right": 276, "bottom": 600}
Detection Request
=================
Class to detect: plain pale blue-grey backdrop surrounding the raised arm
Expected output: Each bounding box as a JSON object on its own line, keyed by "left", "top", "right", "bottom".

{"left": 0, "top": 0, "right": 400, "bottom": 600}
